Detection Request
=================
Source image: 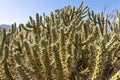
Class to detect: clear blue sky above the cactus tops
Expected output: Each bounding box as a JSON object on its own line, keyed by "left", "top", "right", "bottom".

{"left": 0, "top": 0, "right": 120, "bottom": 24}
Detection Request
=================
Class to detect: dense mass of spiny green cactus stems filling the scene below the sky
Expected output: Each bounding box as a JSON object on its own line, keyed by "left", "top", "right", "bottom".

{"left": 0, "top": 2, "right": 120, "bottom": 80}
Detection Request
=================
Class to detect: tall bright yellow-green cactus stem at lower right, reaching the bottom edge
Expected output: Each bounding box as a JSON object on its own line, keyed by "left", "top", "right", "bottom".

{"left": 91, "top": 39, "right": 105, "bottom": 80}
